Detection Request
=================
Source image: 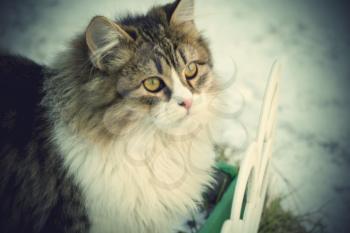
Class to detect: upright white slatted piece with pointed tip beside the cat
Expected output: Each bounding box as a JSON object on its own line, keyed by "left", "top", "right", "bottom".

{"left": 221, "top": 61, "right": 282, "bottom": 233}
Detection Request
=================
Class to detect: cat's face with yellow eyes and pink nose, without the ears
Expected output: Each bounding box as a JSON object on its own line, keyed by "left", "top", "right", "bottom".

{"left": 117, "top": 39, "right": 213, "bottom": 128}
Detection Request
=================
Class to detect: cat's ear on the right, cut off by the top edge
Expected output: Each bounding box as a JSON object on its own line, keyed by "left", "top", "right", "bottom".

{"left": 170, "top": 0, "right": 195, "bottom": 25}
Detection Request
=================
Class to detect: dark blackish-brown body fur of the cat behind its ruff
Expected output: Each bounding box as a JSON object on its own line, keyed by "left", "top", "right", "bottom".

{"left": 0, "top": 56, "right": 89, "bottom": 233}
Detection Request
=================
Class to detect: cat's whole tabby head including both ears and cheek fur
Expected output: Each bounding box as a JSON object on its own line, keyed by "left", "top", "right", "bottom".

{"left": 51, "top": 0, "right": 215, "bottom": 142}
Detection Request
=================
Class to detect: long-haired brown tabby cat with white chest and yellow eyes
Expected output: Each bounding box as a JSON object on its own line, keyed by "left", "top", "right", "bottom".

{"left": 0, "top": 0, "right": 221, "bottom": 233}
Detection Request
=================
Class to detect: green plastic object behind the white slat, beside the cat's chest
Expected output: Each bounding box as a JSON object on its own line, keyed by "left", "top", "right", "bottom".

{"left": 197, "top": 163, "right": 238, "bottom": 233}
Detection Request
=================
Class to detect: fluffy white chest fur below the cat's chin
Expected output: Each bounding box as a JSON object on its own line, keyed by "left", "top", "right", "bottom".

{"left": 55, "top": 124, "right": 214, "bottom": 233}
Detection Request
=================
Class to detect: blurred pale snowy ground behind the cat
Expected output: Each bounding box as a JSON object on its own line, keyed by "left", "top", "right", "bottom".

{"left": 0, "top": 0, "right": 350, "bottom": 233}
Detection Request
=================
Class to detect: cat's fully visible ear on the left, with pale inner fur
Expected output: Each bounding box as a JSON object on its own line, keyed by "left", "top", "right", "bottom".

{"left": 85, "top": 16, "right": 135, "bottom": 70}
